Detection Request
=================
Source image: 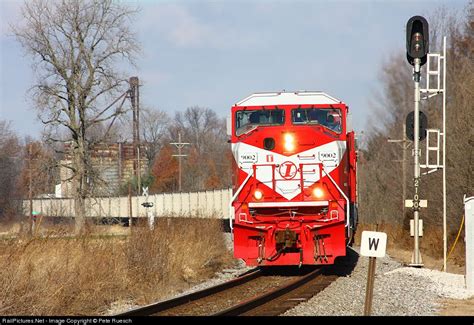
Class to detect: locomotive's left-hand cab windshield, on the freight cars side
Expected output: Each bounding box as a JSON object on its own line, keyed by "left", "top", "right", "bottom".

{"left": 235, "top": 109, "right": 285, "bottom": 136}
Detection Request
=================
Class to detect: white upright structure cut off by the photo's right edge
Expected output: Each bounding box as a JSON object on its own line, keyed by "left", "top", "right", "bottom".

{"left": 464, "top": 196, "right": 474, "bottom": 291}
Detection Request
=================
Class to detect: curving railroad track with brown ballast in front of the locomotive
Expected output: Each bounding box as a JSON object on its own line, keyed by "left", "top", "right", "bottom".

{"left": 115, "top": 247, "right": 358, "bottom": 317}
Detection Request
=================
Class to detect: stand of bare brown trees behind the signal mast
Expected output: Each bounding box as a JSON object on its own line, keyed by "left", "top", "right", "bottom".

{"left": 359, "top": 2, "right": 474, "bottom": 238}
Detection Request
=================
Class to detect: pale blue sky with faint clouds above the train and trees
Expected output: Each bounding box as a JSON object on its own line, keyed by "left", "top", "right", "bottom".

{"left": 0, "top": 0, "right": 467, "bottom": 137}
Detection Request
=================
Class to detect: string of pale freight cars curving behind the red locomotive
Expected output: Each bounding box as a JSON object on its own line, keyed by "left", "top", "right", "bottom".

{"left": 23, "top": 188, "right": 232, "bottom": 219}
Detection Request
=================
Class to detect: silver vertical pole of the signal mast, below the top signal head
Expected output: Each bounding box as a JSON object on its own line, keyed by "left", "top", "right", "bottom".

{"left": 411, "top": 59, "right": 423, "bottom": 267}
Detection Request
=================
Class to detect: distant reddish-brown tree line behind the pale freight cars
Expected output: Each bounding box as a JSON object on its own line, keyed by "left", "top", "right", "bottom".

{"left": 0, "top": 106, "right": 232, "bottom": 208}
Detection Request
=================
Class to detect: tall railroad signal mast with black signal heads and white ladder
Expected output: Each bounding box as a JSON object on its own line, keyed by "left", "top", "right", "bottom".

{"left": 405, "top": 16, "right": 447, "bottom": 271}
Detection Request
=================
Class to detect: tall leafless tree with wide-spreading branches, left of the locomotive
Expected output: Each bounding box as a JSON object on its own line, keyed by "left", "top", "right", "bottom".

{"left": 12, "top": 0, "right": 137, "bottom": 233}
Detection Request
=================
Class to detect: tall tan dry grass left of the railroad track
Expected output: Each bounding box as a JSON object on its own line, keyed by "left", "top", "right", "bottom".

{"left": 0, "top": 219, "right": 232, "bottom": 315}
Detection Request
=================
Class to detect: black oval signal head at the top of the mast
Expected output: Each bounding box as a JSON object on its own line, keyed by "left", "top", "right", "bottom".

{"left": 407, "top": 16, "right": 429, "bottom": 66}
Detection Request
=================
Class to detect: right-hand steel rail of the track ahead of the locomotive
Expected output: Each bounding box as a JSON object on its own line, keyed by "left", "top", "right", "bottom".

{"left": 213, "top": 267, "right": 324, "bottom": 316}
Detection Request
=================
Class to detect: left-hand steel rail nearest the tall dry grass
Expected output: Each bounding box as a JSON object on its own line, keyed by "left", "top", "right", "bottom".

{"left": 114, "top": 269, "right": 262, "bottom": 317}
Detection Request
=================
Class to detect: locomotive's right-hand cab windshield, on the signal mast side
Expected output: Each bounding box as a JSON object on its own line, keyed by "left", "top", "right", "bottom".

{"left": 291, "top": 108, "right": 342, "bottom": 133}
